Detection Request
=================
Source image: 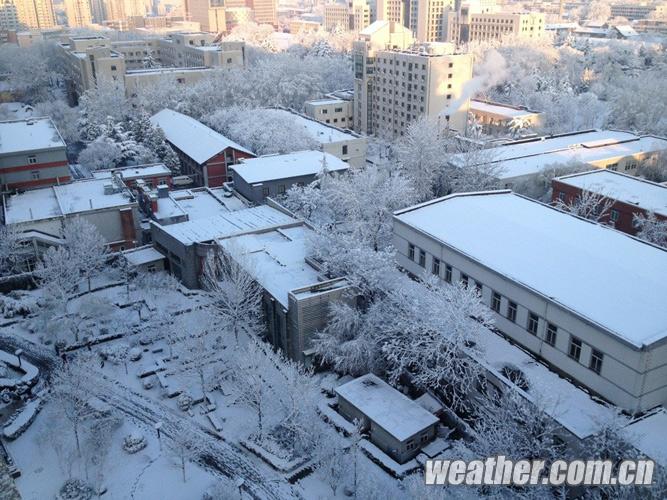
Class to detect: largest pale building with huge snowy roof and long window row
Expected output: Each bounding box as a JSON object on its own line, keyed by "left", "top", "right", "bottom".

{"left": 394, "top": 191, "right": 667, "bottom": 412}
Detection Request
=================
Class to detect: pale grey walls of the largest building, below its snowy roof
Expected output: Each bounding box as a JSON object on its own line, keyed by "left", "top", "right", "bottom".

{"left": 394, "top": 219, "right": 667, "bottom": 412}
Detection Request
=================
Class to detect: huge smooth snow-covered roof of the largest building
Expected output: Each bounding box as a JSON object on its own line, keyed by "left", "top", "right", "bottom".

{"left": 395, "top": 191, "right": 667, "bottom": 347}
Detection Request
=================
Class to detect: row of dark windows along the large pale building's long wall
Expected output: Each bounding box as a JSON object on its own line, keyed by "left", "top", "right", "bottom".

{"left": 408, "top": 243, "right": 604, "bottom": 375}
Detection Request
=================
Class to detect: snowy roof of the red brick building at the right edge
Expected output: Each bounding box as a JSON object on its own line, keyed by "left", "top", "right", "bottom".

{"left": 556, "top": 169, "right": 667, "bottom": 217}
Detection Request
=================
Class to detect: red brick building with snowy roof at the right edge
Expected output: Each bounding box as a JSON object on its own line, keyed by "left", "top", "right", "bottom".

{"left": 552, "top": 169, "right": 667, "bottom": 235}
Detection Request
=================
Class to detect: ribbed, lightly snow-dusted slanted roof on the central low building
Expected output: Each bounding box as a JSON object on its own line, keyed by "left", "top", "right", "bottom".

{"left": 153, "top": 205, "right": 297, "bottom": 245}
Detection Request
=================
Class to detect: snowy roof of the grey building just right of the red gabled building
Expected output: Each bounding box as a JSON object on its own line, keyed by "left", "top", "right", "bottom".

{"left": 231, "top": 151, "right": 349, "bottom": 184}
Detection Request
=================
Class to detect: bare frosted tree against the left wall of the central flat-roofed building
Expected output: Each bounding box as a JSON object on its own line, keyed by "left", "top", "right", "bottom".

{"left": 203, "top": 250, "right": 262, "bottom": 345}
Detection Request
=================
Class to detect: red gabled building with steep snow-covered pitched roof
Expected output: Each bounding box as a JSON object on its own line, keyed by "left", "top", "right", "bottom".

{"left": 151, "top": 109, "right": 255, "bottom": 187}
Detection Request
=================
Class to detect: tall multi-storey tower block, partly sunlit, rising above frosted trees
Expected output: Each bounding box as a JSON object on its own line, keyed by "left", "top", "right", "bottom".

{"left": 354, "top": 21, "right": 472, "bottom": 138}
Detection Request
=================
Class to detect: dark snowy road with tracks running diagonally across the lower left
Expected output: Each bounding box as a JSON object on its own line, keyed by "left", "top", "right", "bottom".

{"left": 0, "top": 335, "right": 299, "bottom": 500}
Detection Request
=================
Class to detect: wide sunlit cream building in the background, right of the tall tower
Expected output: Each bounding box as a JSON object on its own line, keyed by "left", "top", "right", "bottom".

{"left": 446, "top": 6, "right": 545, "bottom": 43}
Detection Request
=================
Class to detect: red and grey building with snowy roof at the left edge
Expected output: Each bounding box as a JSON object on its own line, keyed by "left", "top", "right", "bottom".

{"left": 0, "top": 118, "right": 70, "bottom": 191}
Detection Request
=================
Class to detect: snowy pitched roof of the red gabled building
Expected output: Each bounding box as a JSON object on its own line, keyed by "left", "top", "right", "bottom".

{"left": 151, "top": 109, "right": 253, "bottom": 164}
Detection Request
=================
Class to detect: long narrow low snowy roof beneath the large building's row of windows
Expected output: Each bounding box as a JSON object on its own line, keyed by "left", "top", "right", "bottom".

{"left": 476, "top": 329, "right": 617, "bottom": 439}
